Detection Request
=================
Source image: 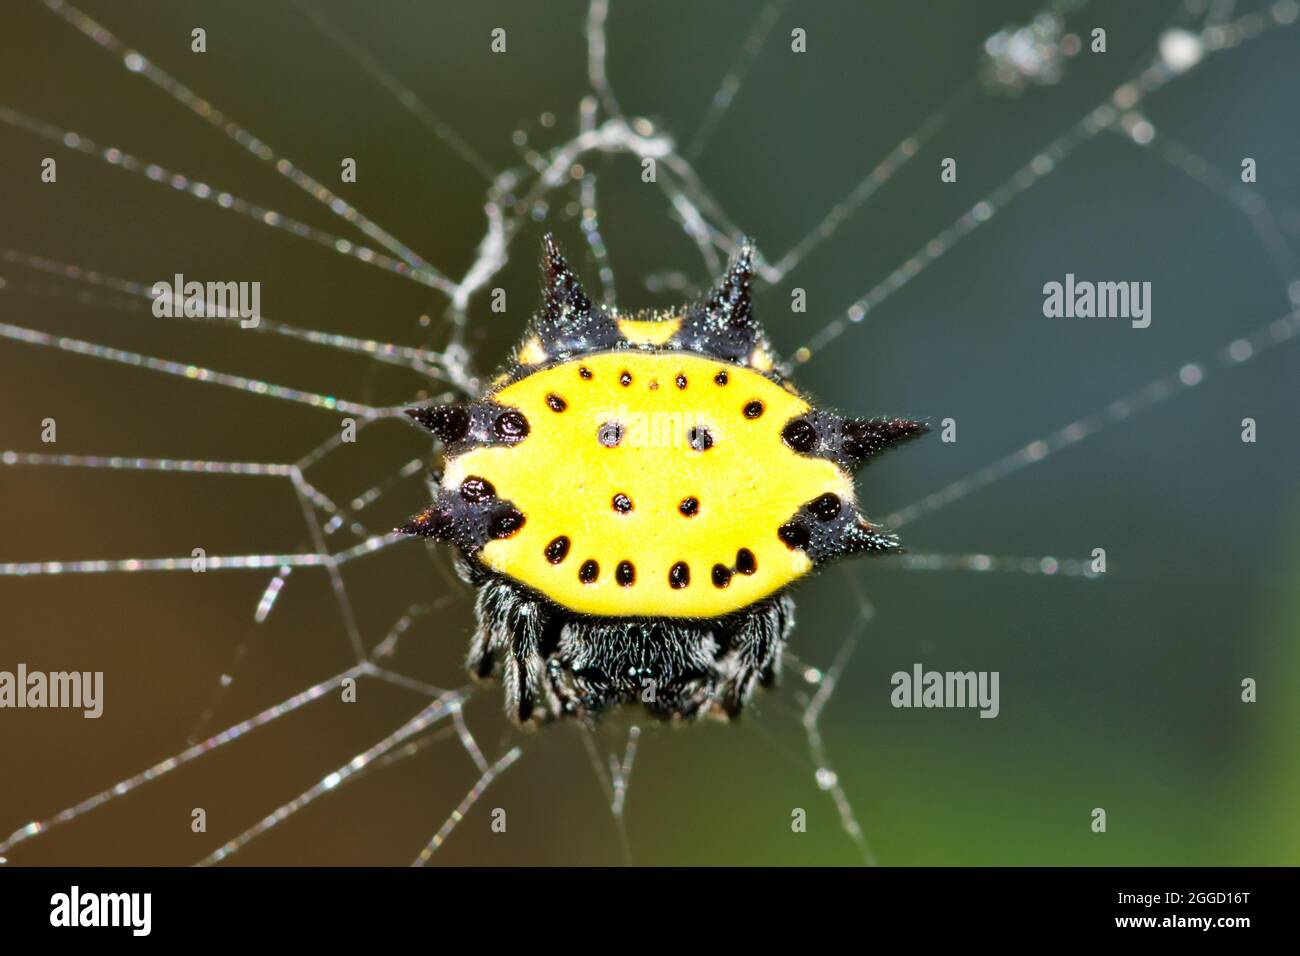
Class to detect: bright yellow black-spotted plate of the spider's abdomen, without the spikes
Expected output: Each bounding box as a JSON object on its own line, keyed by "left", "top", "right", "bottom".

{"left": 443, "top": 350, "right": 853, "bottom": 618}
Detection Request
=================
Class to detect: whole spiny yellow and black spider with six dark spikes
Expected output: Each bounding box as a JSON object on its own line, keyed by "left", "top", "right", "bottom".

{"left": 398, "top": 234, "right": 927, "bottom": 724}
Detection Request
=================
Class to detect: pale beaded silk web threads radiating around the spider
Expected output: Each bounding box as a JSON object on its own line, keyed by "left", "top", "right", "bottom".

{"left": 0, "top": 0, "right": 1300, "bottom": 865}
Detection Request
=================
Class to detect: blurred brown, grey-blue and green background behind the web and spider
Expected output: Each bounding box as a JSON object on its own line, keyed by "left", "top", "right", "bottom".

{"left": 0, "top": 0, "right": 1300, "bottom": 865}
